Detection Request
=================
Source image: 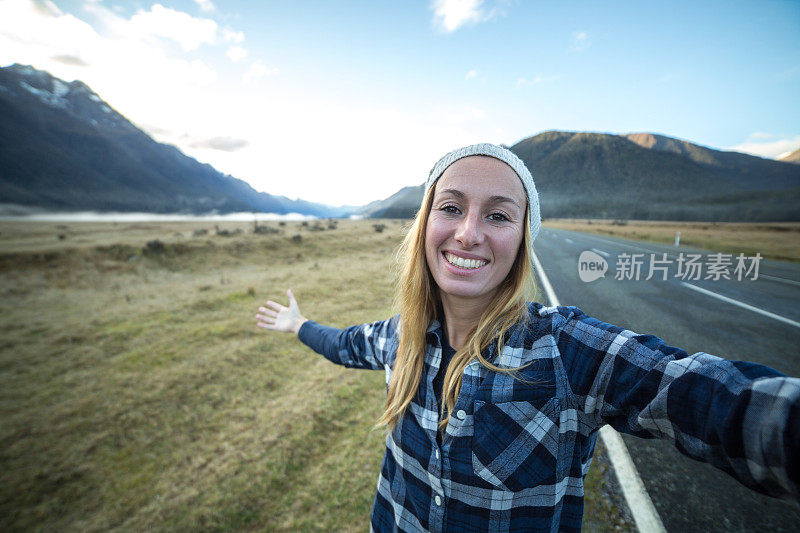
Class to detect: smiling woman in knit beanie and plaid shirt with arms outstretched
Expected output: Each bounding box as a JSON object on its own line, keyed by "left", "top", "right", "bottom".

{"left": 256, "top": 144, "right": 800, "bottom": 531}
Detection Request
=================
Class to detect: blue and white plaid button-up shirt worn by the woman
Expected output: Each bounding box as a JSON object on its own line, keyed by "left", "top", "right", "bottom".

{"left": 299, "top": 303, "right": 800, "bottom": 532}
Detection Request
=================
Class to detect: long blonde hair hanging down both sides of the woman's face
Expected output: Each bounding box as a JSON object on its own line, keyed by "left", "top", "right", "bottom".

{"left": 377, "top": 185, "right": 536, "bottom": 430}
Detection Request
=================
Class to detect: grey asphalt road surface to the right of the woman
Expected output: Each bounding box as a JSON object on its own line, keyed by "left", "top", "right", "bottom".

{"left": 534, "top": 229, "right": 800, "bottom": 532}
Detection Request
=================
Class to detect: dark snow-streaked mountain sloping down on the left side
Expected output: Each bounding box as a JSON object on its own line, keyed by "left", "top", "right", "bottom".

{"left": 0, "top": 64, "right": 348, "bottom": 216}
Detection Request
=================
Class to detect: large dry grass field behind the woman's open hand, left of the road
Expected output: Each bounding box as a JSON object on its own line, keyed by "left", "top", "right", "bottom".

{"left": 0, "top": 221, "right": 625, "bottom": 531}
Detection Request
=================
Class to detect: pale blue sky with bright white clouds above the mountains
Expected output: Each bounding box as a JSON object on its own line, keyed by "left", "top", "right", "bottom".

{"left": 0, "top": 0, "right": 800, "bottom": 205}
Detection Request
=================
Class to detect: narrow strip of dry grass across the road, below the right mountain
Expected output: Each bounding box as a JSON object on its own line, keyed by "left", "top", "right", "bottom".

{"left": 544, "top": 219, "right": 800, "bottom": 263}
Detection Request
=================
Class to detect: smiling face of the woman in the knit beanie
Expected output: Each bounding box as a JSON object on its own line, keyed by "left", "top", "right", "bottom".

{"left": 425, "top": 156, "right": 527, "bottom": 306}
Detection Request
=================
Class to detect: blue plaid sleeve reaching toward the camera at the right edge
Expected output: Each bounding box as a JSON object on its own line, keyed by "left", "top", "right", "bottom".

{"left": 556, "top": 308, "right": 800, "bottom": 498}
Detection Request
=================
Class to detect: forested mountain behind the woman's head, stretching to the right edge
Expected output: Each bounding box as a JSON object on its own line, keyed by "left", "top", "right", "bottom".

{"left": 362, "top": 131, "right": 800, "bottom": 222}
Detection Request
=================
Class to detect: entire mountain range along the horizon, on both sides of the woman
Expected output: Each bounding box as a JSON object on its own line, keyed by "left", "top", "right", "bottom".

{"left": 0, "top": 65, "right": 800, "bottom": 221}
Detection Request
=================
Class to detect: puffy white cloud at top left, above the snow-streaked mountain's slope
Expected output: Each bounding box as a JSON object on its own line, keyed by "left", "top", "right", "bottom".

{"left": 127, "top": 4, "right": 217, "bottom": 51}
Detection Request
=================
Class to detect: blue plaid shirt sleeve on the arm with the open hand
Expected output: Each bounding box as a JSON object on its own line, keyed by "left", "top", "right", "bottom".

{"left": 297, "top": 316, "right": 398, "bottom": 370}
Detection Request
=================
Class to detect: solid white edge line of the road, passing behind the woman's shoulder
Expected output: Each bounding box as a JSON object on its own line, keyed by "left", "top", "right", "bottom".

{"left": 531, "top": 252, "right": 667, "bottom": 533}
